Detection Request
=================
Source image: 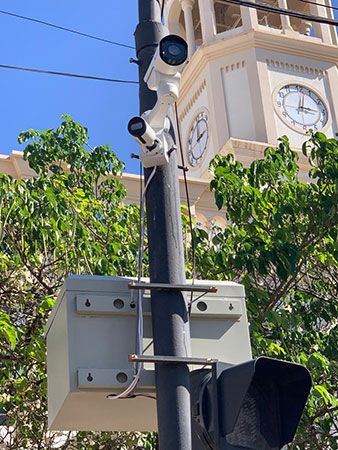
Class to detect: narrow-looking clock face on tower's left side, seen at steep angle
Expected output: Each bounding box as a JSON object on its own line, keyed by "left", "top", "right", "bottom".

{"left": 188, "top": 112, "right": 209, "bottom": 167}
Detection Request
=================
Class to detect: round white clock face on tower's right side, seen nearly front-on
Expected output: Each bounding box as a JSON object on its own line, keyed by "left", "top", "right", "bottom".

{"left": 276, "top": 84, "right": 328, "bottom": 132}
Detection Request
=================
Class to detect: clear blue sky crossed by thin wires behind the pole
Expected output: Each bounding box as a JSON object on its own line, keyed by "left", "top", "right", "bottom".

{"left": 0, "top": 0, "right": 338, "bottom": 173}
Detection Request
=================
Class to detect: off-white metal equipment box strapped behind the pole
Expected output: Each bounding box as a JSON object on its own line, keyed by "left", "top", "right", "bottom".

{"left": 45, "top": 276, "right": 251, "bottom": 431}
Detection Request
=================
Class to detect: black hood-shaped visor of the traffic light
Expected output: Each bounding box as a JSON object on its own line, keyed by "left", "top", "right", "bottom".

{"left": 217, "top": 357, "right": 311, "bottom": 450}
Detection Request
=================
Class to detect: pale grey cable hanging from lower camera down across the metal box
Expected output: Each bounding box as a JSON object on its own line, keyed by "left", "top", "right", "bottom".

{"left": 107, "top": 166, "right": 157, "bottom": 400}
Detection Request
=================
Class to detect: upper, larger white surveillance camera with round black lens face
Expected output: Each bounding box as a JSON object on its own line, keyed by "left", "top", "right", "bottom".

{"left": 144, "top": 34, "right": 188, "bottom": 90}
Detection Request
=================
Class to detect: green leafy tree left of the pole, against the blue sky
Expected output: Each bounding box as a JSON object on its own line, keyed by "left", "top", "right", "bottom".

{"left": 0, "top": 116, "right": 155, "bottom": 450}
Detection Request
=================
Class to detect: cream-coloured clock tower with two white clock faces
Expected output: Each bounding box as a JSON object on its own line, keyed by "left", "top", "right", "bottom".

{"left": 164, "top": 0, "right": 338, "bottom": 179}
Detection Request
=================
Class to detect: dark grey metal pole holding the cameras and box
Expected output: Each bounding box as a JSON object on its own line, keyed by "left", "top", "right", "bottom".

{"left": 135, "top": 0, "right": 192, "bottom": 450}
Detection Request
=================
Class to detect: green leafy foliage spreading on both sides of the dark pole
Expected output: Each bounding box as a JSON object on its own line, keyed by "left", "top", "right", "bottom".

{"left": 0, "top": 116, "right": 338, "bottom": 450}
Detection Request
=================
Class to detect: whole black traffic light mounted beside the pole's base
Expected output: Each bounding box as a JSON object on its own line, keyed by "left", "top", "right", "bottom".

{"left": 190, "top": 357, "right": 312, "bottom": 450}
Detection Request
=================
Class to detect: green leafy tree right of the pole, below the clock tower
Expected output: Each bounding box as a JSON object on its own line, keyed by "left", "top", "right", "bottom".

{"left": 194, "top": 132, "right": 338, "bottom": 450}
